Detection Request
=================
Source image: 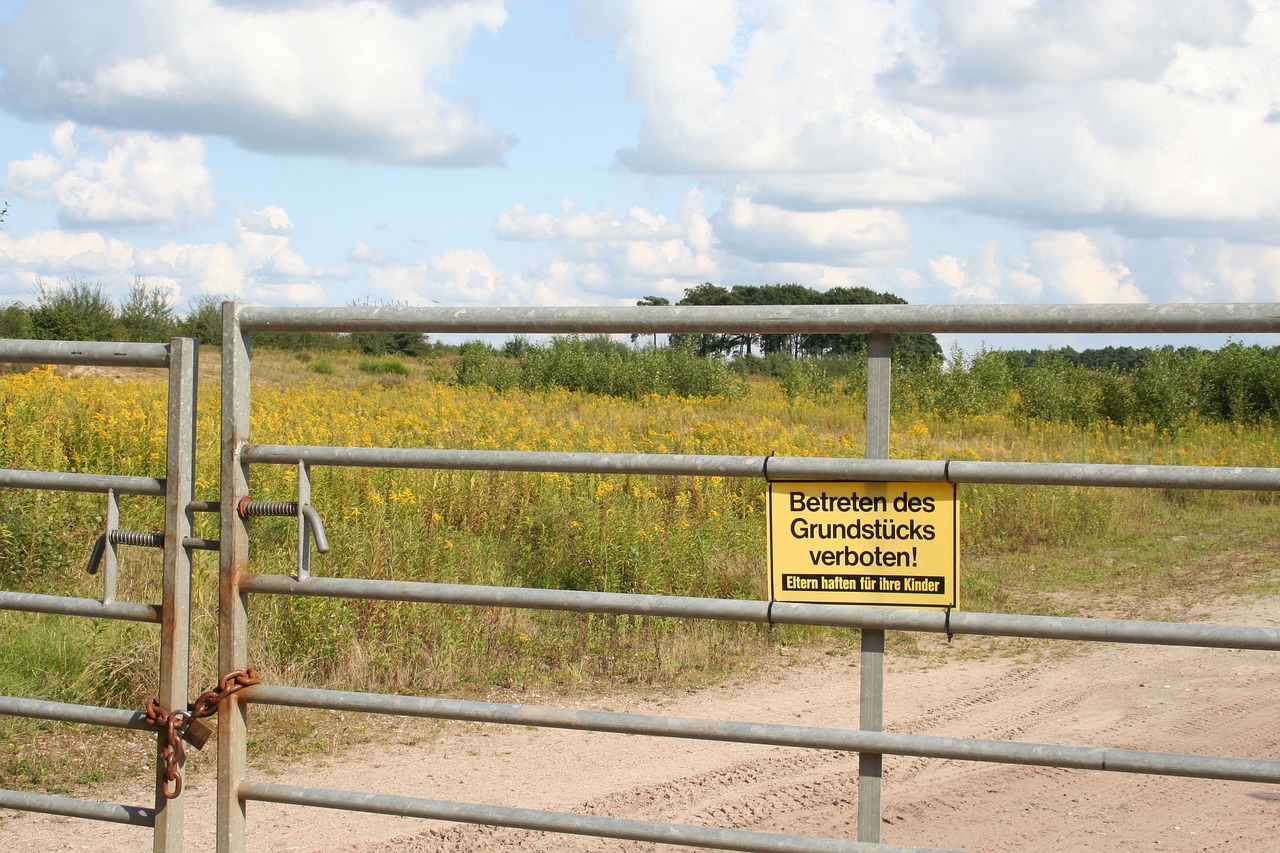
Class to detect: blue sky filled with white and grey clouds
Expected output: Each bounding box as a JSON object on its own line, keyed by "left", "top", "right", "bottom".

{"left": 0, "top": 0, "right": 1280, "bottom": 345}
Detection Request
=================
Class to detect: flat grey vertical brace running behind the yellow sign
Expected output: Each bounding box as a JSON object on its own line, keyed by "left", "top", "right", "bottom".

{"left": 858, "top": 334, "right": 893, "bottom": 843}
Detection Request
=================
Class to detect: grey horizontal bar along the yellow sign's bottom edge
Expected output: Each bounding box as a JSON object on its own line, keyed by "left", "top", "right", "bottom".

{"left": 241, "top": 574, "right": 1280, "bottom": 651}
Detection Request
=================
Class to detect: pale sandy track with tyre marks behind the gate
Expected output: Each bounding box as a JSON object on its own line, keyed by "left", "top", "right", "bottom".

{"left": 0, "top": 598, "right": 1280, "bottom": 853}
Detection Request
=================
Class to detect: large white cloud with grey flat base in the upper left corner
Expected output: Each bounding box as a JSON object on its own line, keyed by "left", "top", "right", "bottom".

{"left": 0, "top": 0, "right": 515, "bottom": 165}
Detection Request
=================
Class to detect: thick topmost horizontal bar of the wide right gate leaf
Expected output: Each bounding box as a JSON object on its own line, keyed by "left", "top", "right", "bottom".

{"left": 239, "top": 302, "right": 1280, "bottom": 334}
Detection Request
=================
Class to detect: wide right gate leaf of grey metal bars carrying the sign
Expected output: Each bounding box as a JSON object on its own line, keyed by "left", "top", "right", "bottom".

{"left": 218, "top": 302, "right": 1280, "bottom": 853}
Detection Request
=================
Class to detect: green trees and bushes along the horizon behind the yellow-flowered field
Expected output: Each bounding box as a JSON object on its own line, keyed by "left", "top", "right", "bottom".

{"left": 0, "top": 279, "right": 1280, "bottom": 428}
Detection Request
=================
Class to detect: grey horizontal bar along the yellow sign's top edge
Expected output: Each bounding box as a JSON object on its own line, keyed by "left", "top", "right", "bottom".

{"left": 242, "top": 444, "right": 1280, "bottom": 491}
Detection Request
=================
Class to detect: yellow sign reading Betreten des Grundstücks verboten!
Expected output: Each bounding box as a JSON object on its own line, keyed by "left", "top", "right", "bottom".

{"left": 769, "top": 482, "right": 960, "bottom": 607}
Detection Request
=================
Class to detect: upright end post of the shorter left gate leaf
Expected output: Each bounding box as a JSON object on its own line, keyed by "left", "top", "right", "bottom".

{"left": 154, "top": 338, "right": 198, "bottom": 853}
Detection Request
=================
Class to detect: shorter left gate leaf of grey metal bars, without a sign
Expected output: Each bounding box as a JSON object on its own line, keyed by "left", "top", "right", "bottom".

{"left": 0, "top": 338, "right": 198, "bottom": 853}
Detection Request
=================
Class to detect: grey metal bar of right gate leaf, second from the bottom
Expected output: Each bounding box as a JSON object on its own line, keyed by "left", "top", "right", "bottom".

{"left": 242, "top": 685, "right": 1280, "bottom": 783}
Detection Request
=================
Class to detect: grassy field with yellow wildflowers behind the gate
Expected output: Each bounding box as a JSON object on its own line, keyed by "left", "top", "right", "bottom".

{"left": 0, "top": 351, "right": 1280, "bottom": 790}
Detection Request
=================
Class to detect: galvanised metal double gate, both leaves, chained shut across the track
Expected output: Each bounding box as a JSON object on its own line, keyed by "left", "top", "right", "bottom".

{"left": 0, "top": 302, "right": 1280, "bottom": 853}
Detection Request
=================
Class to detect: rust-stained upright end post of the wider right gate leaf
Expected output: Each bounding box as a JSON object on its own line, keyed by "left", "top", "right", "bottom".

{"left": 218, "top": 302, "right": 250, "bottom": 853}
